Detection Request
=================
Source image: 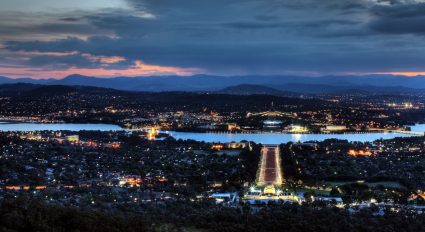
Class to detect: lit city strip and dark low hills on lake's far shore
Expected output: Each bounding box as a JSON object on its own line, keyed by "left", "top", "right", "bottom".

{"left": 0, "top": 84, "right": 425, "bottom": 133}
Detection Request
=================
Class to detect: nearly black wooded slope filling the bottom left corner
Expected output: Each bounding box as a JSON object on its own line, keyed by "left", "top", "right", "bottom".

{"left": 0, "top": 198, "right": 147, "bottom": 232}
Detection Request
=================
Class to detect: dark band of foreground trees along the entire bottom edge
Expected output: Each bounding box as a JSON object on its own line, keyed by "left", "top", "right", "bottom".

{"left": 0, "top": 199, "right": 425, "bottom": 232}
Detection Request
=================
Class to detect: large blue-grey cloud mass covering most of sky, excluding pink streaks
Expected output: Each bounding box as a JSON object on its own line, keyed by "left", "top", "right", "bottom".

{"left": 4, "top": 0, "right": 425, "bottom": 74}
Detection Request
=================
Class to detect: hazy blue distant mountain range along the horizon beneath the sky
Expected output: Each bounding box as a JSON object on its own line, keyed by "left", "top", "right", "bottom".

{"left": 0, "top": 75, "right": 425, "bottom": 95}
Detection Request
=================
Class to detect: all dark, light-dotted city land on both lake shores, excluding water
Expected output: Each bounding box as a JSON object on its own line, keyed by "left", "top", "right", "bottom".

{"left": 0, "top": 84, "right": 425, "bottom": 231}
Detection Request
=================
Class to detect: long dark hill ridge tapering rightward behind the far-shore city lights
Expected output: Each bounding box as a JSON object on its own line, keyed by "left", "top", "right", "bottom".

{"left": 0, "top": 84, "right": 328, "bottom": 109}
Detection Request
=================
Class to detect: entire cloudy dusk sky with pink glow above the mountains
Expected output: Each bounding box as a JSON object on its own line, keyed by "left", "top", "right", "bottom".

{"left": 0, "top": 0, "right": 425, "bottom": 78}
